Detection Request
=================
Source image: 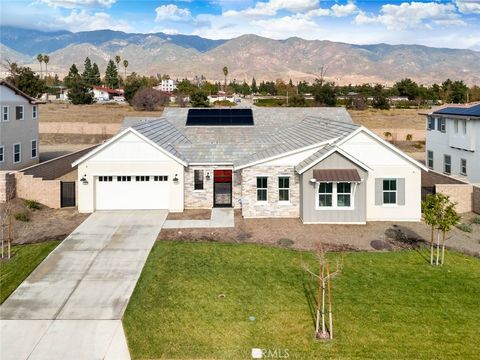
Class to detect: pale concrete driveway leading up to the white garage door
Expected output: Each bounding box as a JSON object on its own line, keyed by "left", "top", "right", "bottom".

{"left": 0, "top": 210, "right": 168, "bottom": 360}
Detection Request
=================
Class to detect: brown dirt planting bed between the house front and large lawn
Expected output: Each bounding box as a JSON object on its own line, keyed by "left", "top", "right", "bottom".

{"left": 158, "top": 211, "right": 480, "bottom": 256}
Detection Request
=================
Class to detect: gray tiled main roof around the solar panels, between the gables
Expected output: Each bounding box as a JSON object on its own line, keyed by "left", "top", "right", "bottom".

{"left": 124, "top": 106, "right": 358, "bottom": 166}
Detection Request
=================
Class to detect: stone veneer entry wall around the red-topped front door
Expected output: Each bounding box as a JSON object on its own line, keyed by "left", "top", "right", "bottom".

{"left": 185, "top": 166, "right": 242, "bottom": 209}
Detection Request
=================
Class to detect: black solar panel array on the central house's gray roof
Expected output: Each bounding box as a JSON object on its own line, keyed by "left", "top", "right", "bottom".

{"left": 186, "top": 108, "right": 253, "bottom": 126}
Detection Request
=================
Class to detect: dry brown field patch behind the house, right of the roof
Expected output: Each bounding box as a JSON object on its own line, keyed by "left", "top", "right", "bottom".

{"left": 348, "top": 109, "right": 428, "bottom": 130}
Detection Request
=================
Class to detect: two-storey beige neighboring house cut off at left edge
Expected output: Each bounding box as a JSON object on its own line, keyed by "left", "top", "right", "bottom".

{"left": 0, "top": 80, "right": 39, "bottom": 170}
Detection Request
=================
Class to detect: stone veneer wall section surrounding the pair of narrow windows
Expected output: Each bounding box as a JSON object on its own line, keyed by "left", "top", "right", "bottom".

{"left": 242, "top": 166, "right": 300, "bottom": 218}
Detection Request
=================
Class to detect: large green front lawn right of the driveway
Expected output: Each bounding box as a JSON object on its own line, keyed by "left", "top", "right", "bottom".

{"left": 123, "top": 242, "right": 480, "bottom": 359}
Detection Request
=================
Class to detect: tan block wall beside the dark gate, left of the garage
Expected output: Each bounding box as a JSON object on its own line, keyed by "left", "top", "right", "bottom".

{"left": 15, "top": 172, "right": 61, "bottom": 209}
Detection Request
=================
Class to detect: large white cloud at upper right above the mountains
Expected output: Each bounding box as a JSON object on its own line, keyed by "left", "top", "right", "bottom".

{"left": 355, "top": 1, "right": 463, "bottom": 30}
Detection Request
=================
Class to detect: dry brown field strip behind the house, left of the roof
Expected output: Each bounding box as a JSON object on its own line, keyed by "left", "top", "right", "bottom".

{"left": 40, "top": 103, "right": 162, "bottom": 123}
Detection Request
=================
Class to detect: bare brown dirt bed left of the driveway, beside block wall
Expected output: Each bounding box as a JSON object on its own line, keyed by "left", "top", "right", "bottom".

{"left": 0, "top": 199, "right": 89, "bottom": 244}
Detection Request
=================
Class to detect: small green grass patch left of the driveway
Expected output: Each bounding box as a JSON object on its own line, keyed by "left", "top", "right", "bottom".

{"left": 0, "top": 241, "right": 60, "bottom": 304}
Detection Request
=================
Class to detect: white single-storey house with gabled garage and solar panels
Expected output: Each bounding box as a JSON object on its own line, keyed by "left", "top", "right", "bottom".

{"left": 74, "top": 107, "right": 426, "bottom": 224}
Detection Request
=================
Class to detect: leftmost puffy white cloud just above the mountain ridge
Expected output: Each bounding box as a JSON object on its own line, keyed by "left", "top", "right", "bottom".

{"left": 48, "top": 10, "right": 131, "bottom": 31}
